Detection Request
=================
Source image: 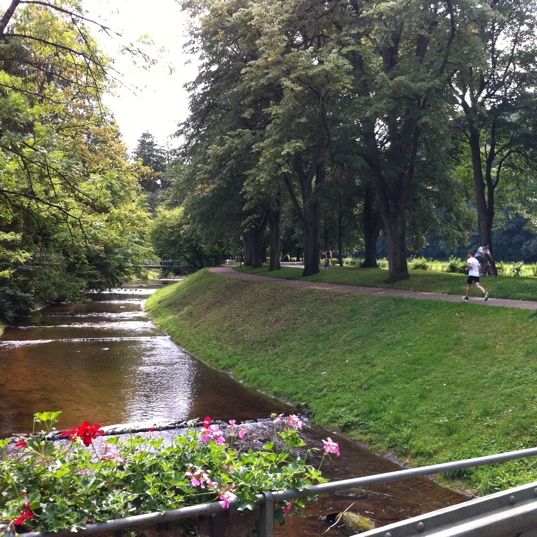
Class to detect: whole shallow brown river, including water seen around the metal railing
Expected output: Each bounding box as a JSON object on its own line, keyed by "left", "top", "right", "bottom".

{"left": 0, "top": 286, "right": 466, "bottom": 537}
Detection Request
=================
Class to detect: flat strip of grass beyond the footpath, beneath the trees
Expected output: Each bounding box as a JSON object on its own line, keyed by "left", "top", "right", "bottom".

{"left": 242, "top": 267, "right": 537, "bottom": 300}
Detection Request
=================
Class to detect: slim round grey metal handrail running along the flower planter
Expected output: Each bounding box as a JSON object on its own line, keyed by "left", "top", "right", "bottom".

{"left": 7, "top": 448, "right": 537, "bottom": 537}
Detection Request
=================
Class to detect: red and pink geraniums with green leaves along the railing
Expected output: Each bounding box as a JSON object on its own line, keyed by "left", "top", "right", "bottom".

{"left": 0, "top": 412, "right": 339, "bottom": 535}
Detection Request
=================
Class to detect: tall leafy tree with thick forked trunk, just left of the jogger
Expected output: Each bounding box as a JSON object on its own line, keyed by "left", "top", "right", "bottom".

{"left": 342, "top": 0, "right": 462, "bottom": 281}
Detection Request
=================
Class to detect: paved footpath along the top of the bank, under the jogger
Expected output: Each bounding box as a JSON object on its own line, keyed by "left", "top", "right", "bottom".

{"left": 209, "top": 267, "right": 537, "bottom": 310}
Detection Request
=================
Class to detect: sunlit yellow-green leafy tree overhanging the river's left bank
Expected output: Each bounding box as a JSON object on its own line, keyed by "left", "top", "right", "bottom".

{"left": 0, "top": 0, "right": 152, "bottom": 318}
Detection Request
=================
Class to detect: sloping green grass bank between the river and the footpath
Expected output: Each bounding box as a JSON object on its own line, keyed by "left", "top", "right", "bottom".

{"left": 147, "top": 271, "right": 537, "bottom": 491}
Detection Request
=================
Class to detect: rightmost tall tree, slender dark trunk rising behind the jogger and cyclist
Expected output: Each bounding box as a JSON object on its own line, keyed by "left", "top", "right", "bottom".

{"left": 451, "top": 0, "right": 537, "bottom": 258}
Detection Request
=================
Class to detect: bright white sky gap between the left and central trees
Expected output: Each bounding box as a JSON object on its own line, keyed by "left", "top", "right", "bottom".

{"left": 80, "top": 0, "right": 196, "bottom": 151}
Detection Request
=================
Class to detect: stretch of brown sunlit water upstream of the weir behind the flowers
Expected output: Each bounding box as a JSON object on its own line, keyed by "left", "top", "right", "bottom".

{"left": 0, "top": 289, "right": 284, "bottom": 436}
